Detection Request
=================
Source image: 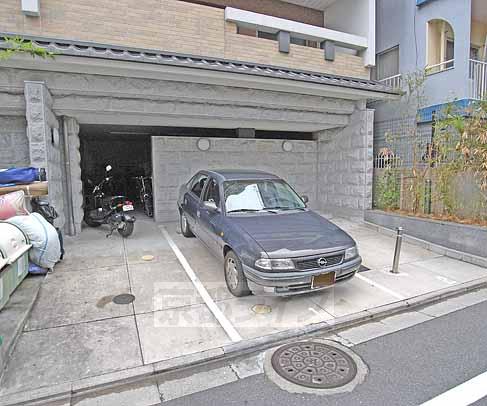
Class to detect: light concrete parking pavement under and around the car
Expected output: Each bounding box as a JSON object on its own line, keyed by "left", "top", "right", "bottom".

{"left": 0, "top": 219, "right": 487, "bottom": 403}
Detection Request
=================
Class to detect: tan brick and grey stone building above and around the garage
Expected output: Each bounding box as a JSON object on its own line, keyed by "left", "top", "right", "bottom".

{"left": 0, "top": 0, "right": 397, "bottom": 234}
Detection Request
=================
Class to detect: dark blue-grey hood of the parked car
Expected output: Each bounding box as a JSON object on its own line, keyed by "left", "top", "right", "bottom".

{"left": 231, "top": 211, "right": 355, "bottom": 258}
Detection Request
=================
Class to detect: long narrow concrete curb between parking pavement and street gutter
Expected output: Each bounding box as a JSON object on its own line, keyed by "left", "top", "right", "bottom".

{"left": 0, "top": 277, "right": 487, "bottom": 406}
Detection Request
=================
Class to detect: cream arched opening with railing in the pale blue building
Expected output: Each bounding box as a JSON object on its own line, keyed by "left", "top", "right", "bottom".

{"left": 426, "top": 19, "right": 455, "bottom": 74}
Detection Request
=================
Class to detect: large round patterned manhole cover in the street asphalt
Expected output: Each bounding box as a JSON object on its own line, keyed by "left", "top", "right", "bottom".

{"left": 271, "top": 341, "right": 357, "bottom": 389}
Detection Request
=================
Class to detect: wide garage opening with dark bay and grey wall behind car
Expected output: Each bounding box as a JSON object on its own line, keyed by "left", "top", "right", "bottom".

{"left": 80, "top": 125, "right": 318, "bottom": 222}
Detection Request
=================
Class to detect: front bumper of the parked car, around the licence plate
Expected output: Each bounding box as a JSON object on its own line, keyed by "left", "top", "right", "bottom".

{"left": 242, "top": 257, "right": 362, "bottom": 296}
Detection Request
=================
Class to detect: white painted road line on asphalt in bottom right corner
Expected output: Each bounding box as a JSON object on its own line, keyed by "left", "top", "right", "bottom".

{"left": 421, "top": 372, "right": 487, "bottom": 406}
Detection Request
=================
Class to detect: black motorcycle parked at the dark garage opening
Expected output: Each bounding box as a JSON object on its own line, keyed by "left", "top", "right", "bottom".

{"left": 84, "top": 165, "right": 135, "bottom": 238}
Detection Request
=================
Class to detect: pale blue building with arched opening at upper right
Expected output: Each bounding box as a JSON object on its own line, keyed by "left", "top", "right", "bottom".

{"left": 373, "top": 0, "right": 487, "bottom": 153}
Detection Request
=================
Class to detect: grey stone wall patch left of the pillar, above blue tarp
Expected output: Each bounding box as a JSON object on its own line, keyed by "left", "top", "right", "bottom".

{"left": 0, "top": 116, "right": 30, "bottom": 169}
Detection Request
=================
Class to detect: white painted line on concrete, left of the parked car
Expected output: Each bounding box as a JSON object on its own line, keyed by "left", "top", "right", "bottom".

{"left": 160, "top": 226, "right": 242, "bottom": 342}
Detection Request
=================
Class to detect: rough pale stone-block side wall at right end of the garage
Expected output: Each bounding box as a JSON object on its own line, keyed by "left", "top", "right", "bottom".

{"left": 317, "top": 103, "right": 373, "bottom": 218}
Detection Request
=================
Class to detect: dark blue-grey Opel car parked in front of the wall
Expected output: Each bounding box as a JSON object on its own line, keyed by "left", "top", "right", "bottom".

{"left": 178, "top": 170, "right": 362, "bottom": 296}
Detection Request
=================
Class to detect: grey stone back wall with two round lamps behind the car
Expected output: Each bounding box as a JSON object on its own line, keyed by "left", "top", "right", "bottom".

{"left": 152, "top": 137, "right": 317, "bottom": 222}
